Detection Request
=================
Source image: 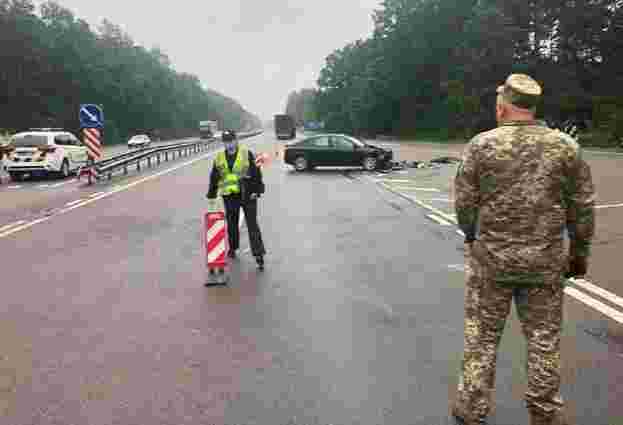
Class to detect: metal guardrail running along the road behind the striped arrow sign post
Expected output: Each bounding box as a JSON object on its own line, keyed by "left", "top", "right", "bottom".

{"left": 78, "top": 130, "right": 263, "bottom": 183}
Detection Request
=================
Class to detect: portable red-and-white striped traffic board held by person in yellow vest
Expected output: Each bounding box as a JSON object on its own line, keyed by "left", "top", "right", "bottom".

{"left": 203, "top": 200, "right": 229, "bottom": 286}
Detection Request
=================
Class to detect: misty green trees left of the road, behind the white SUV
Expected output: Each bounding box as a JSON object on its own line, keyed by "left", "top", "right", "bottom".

{"left": 0, "top": 0, "right": 260, "bottom": 143}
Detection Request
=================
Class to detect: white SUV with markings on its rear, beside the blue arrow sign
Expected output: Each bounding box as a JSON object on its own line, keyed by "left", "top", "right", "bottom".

{"left": 5, "top": 128, "right": 88, "bottom": 181}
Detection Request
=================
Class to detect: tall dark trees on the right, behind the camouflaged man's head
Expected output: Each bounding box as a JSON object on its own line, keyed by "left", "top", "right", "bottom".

{"left": 292, "top": 0, "right": 623, "bottom": 146}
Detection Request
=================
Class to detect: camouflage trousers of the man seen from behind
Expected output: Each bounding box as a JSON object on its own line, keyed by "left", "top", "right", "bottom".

{"left": 456, "top": 248, "right": 564, "bottom": 421}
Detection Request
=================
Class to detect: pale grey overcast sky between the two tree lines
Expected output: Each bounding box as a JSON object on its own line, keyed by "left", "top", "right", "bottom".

{"left": 37, "top": 0, "right": 381, "bottom": 120}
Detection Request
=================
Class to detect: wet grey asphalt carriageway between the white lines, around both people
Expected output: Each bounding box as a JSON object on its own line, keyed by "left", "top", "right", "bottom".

{"left": 0, "top": 133, "right": 623, "bottom": 425}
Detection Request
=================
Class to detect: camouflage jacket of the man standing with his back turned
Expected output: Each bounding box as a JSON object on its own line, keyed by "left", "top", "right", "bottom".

{"left": 455, "top": 121, "right": 595, "bottom": 283}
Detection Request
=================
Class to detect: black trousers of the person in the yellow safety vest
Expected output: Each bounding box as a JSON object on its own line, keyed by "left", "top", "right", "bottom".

{"left": 223, "top": 195, "right": 266, "bottom": 257}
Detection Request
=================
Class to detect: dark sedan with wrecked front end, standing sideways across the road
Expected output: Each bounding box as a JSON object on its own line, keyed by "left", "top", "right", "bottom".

{"left": 284, "top": 134, "right": 394, "bottom": 171}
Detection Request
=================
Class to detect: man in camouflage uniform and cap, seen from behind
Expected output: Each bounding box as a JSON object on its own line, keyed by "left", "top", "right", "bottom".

{"left": 452, "top": 74, "right": 594, "bottom": 425}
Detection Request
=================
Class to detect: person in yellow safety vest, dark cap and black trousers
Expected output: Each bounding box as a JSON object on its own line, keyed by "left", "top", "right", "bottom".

{"left": 207, "top": 130, "right": 266, "bottom": 270}
